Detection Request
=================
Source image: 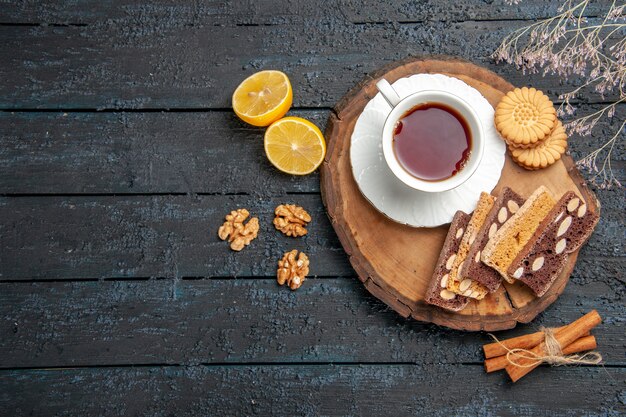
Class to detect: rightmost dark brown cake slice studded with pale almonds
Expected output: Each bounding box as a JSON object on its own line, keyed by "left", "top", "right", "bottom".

{"left": 507, "top": 191, "right": 600, "bottom": 297}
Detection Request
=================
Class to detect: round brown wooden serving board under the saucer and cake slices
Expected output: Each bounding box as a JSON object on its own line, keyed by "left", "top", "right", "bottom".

{"left": 321, "top": 56, "right": 600, "bottom": 331}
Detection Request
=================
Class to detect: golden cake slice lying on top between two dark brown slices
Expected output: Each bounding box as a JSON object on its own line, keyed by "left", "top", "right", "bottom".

{"left": 480, "top": 186, "right": 556, "bottom": 283}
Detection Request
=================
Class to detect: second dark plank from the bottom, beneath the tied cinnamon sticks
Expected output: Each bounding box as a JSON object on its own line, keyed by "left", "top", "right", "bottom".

{"left": 0, "top": 276, "right": 626, "bottom": 368}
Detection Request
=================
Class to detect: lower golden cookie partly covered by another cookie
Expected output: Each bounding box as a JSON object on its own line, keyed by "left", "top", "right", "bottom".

{"left": 509, "top": 120, "right": 567, "bottom": 170}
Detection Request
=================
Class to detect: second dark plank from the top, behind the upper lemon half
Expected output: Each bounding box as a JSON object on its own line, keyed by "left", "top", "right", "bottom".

{"left": 0, "top": 16, "right": 616, "bottom": 109}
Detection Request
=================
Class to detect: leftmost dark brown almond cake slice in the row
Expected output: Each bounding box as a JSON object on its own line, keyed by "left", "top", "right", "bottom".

{"left": 425, "top": 211, "right": 470, "bottom": 311}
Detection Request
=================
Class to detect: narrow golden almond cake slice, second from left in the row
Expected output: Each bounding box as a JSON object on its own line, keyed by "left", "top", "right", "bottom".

{"left": 447, "top": 192, "right": 495, "bottom": 300}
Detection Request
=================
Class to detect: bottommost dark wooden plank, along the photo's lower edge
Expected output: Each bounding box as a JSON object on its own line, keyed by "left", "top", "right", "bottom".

{"left": 0, "top": 364, "right": 626, "bottom": 417}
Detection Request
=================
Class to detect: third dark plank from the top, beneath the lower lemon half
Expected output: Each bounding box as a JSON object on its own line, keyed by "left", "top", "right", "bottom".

{"left": 0, "top": 104, "right": 626, "bottom": 194}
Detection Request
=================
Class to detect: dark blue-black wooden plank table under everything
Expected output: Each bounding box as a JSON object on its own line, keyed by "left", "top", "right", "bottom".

{"left": 0, "top": 0, "right": 626, "bottom": 416}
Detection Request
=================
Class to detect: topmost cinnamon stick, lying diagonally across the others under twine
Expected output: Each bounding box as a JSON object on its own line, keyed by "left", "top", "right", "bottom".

{"left": 505, "top": 310, "right": 602, "bottom": 382}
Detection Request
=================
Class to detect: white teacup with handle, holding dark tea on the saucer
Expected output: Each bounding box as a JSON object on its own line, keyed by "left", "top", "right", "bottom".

{"left": 376, "top": 79, "right": 485, "bottom": 193}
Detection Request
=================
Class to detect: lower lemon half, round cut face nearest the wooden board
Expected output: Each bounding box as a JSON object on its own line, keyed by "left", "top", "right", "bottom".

{"left": 265, "top": 117, "right": 326, "bottom": 175}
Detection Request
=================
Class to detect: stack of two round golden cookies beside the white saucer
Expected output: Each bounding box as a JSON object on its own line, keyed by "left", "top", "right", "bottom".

{"left": 495, "top": 87, "right": 567, "bottom": 170}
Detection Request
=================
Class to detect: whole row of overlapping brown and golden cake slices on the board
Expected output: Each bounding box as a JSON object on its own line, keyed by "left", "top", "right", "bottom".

{"left": 425, "top": 186, "right": 599, "bottom": 311}
